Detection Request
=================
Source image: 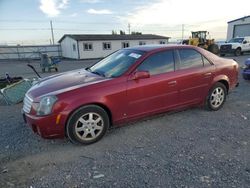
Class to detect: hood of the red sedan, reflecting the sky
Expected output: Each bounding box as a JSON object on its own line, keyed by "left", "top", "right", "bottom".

{"left": 27, "top": 69, "right": 109, "bottom": 98}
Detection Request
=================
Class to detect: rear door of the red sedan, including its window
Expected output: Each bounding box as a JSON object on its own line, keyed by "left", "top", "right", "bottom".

{"left": 176, "top": 48, "right": 214, "bottom": 105}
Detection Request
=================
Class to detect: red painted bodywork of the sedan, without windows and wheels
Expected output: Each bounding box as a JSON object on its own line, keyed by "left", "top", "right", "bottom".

{"left": 22, "top": 45, "right": 238, "bottom": 138}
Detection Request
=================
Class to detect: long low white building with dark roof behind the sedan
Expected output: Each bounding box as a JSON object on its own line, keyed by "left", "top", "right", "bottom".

{"left": 58, "top": 34, "right": 169, "bottom": 59}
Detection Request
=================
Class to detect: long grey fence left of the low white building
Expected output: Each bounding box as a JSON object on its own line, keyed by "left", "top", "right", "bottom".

{"left": 0, "top": 45, "right": 62, "bottom": 60}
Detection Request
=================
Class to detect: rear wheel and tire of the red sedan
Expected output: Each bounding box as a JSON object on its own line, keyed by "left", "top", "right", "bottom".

{"left": 206, "top": 82, "right": 227, "bottom": 111}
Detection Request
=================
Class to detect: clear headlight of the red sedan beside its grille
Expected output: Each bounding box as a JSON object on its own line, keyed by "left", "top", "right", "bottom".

{"left": 33, "top": 96, "right": 57, "bottom": 116}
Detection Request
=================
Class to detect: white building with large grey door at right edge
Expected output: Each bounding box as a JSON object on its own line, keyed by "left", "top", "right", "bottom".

{"left": 227, "top": 16, "right": 250, "bottom": 41}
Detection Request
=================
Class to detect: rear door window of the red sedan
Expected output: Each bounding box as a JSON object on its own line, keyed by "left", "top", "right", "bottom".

{"left": 179, "top": 49, "right": 203, "bottom": 69}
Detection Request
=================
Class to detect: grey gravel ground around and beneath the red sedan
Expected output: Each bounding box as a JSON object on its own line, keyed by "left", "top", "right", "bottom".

{"left": 0, "top": 55, "right": 250, "bottom": 188}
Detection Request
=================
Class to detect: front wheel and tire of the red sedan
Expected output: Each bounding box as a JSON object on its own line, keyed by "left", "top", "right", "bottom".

{"left": 66, "top": 105, "right": 110, "bottom": 144}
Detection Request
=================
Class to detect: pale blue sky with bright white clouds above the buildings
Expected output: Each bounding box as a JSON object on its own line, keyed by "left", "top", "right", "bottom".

{"left": 0, "top": 0, "right": 250, "bottom": 45}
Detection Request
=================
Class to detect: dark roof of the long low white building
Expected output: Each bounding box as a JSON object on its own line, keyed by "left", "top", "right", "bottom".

{"left": 58, "top": 34, "right": 170, "bottom": 43}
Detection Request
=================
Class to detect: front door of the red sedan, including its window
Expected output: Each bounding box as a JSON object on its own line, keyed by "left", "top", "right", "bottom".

{"left": 127, "top": 50, "right": 179, "bottom": 117}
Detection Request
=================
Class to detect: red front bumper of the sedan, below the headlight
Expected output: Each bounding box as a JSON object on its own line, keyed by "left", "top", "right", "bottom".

{"left": 22, "top": 112, "right": 67, "bottom": 138}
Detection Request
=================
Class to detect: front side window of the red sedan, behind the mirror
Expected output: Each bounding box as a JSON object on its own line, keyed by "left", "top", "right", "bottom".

{"left": 137, "top": 51, "right": 174, "bottom": 75}
